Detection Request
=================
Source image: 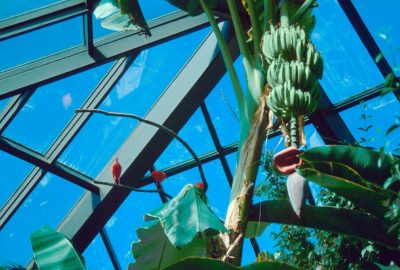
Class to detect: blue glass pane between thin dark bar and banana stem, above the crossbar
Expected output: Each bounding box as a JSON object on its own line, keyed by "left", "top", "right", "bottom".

{"left": 206, "top": 57, "right": 245, "bottom": 146}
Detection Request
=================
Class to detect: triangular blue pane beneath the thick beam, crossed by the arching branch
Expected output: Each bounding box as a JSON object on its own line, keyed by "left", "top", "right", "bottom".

{"left": 155, "top": 109, "right": 215, "bottom": 168}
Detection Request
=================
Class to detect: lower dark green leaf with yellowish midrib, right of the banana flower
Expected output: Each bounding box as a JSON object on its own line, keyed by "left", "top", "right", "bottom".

{"left": 297, "top": 162, "right": 390, "bottom": 217}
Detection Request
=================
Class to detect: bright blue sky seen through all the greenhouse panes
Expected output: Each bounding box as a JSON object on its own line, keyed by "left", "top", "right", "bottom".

{"left": 0, "top": 0, "right": 400, "bottom": 269}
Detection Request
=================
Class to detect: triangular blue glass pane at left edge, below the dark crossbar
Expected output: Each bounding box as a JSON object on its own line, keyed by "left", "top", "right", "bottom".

{"left": 0, "top": 151, "right": 33, "bottom": 208}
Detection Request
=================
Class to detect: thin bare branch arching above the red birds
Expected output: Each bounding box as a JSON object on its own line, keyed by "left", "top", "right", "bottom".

{"left": 75, "top": 109, "right": 208, "bottom": 193}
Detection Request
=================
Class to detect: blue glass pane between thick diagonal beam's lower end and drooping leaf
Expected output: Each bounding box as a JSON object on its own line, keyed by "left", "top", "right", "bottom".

{"left": 105, "top": 192, "right": 162, "bottom": 269}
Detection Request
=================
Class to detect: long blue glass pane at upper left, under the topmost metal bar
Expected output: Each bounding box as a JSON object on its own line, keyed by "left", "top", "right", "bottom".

{"left": 0, "top": 16, "right": 83, "bottom": 71}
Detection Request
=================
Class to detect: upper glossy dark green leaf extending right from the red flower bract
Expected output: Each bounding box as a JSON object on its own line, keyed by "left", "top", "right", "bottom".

{"left": 299, "top": 145, "right": 398, "bottom": 190}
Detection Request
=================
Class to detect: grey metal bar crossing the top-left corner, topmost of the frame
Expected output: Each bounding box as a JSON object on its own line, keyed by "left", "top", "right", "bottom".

{"left": 0, "top": 0, "right": 87, "bottom": 41}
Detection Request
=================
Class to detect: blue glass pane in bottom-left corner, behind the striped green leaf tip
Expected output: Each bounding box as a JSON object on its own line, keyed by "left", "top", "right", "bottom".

{"left": 0, "top": 173, "right": 84, "bottom": 265}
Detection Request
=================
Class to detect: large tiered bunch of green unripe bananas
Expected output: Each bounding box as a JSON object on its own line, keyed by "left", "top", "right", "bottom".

{"left": 262, "top": 26, "right": 323, "bottom": 120}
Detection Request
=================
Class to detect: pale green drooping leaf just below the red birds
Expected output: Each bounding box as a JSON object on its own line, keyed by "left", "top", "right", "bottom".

{"left": 145, "top": 184, "right": 228, "bottom": 247}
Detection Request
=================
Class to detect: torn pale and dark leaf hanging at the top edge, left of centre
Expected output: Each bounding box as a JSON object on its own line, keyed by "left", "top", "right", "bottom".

{"left": 93, "top": 0, "right": 151, "bottom": 36}
